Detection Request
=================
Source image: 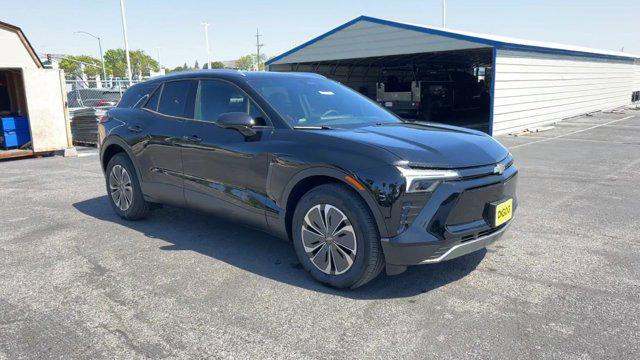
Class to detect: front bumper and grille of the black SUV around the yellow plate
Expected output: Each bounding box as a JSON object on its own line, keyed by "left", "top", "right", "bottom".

{"left": 382, "top": 166, "right": 517, "bottom": 266}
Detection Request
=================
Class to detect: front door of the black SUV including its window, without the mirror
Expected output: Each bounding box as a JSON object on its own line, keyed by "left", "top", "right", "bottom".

{"left": 182, "top": 79, "right": 275, "bottom": 228}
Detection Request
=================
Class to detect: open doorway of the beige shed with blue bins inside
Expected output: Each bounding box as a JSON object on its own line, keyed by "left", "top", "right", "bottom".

{"left": 0, "top": 69, "right": 33, "bottom": 159}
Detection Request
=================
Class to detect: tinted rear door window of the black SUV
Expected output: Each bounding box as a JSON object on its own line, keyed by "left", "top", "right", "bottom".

{"left": 158, "top": 80, "right": 197, "bottom": 118}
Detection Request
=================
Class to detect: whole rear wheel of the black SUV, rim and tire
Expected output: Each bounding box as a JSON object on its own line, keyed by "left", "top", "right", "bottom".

{"left": 106, "top": 153, "right": 149, "bottom": 220}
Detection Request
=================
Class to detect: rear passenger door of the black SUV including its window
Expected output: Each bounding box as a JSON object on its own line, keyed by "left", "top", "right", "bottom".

{"left": 138, "top": 80, "right": 198, "bottom": 206}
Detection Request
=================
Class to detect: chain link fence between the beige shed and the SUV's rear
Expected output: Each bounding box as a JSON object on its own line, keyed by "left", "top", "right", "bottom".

{"left": 66, "top": 79, "right": 141, "bottom": 109}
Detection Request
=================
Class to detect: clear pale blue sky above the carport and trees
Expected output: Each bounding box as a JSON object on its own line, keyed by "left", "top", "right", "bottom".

{"left": 0, "top": 0, "right": 640, "bottom": 67}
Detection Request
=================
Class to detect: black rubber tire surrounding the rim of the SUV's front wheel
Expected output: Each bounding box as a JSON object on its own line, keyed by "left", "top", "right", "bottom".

{"left": 291, "top": 183, "right": 385, "bottom": 289}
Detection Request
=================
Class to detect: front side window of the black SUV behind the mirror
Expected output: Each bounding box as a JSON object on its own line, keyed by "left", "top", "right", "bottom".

{"left": 195, "top": 80, "right": 266, "bottom": 125}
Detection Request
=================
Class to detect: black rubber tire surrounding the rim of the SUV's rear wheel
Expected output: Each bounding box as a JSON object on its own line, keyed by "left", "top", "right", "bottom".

{"left": 105, "top": 153, "right": 149, "bottom": 220}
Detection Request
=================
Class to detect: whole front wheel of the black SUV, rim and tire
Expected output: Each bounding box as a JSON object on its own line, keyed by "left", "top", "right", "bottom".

{"left": 292, "top": 184, "right": 384, "bottom": 289}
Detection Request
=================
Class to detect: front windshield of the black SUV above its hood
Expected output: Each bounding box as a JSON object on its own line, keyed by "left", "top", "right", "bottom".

{"left": 249, "top": 77, "right": 401, "bottom": 127}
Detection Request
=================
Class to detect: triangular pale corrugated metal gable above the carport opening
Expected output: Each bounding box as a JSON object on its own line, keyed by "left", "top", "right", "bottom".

{"left": 273, "top": 21, "right": 488, "bottom": 65}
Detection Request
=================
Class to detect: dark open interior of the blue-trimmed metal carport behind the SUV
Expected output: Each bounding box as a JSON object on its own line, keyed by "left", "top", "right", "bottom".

{"left": 269, "top": 48, "right": 493, "bottom": 133}
